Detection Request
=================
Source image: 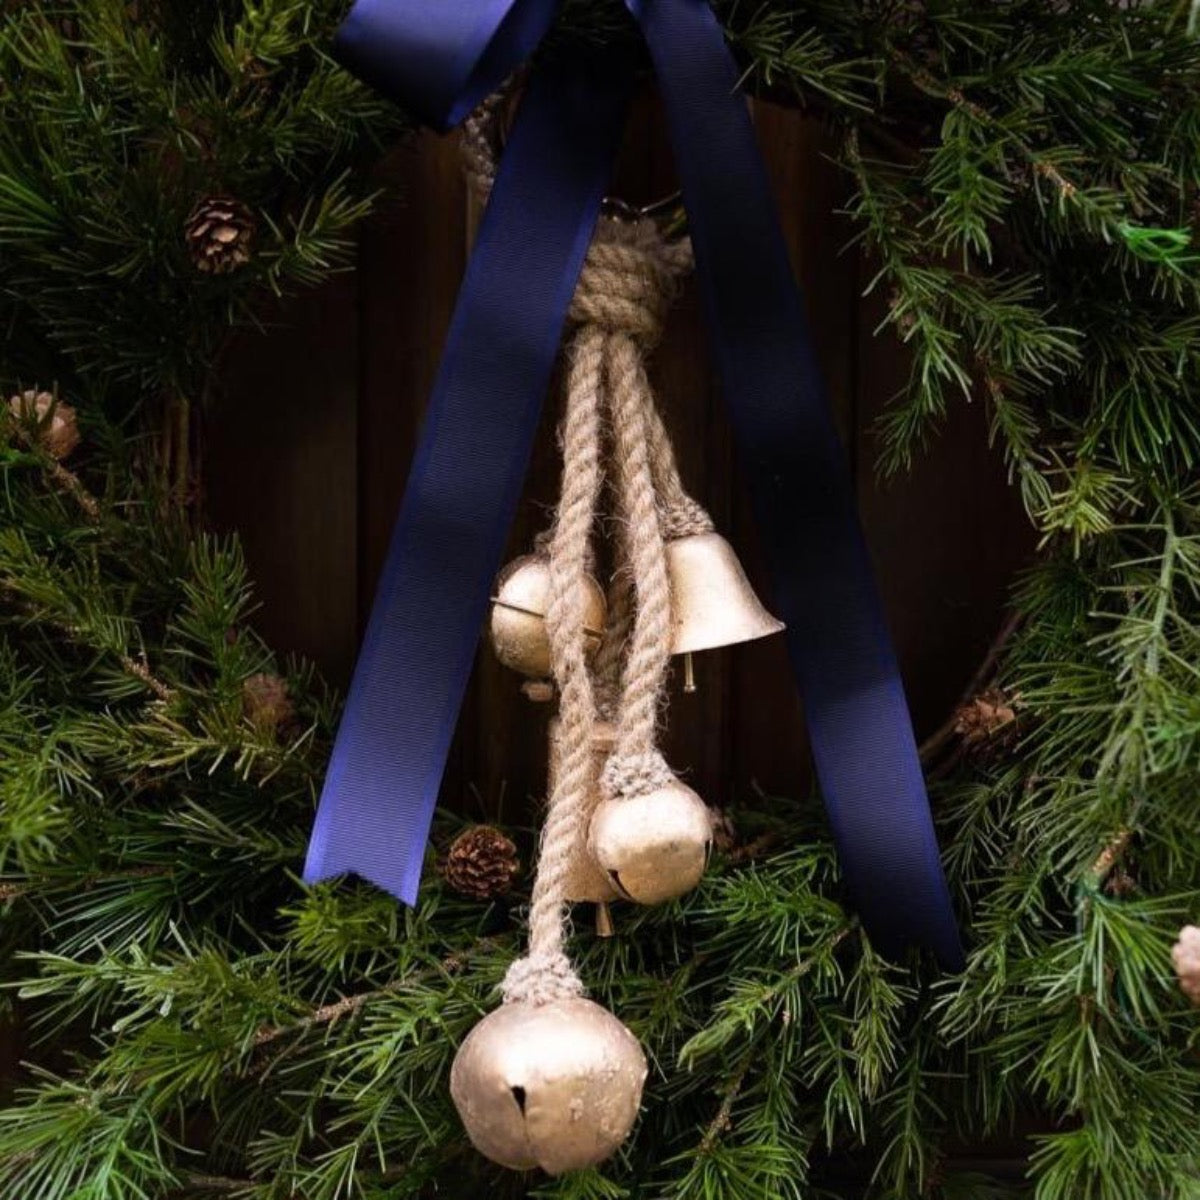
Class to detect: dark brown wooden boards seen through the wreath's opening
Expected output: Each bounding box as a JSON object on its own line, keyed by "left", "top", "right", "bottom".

{"left": 205, "top": 95, "right": 1030, "bottom": 816}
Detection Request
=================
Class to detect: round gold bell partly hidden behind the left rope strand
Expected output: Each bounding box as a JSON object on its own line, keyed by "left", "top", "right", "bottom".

{"left": 491, "top": 554, "right": 605, "bottom": 679}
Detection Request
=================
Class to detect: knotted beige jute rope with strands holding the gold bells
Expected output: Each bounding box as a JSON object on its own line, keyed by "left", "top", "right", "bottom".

{"left": 463, "top": 104, "right": 712, "bottom": 1004}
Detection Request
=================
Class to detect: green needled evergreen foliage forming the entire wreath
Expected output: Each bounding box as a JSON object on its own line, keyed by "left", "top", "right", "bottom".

{"left": 0, "top": 0, "right": 1200, "bottom": 1200}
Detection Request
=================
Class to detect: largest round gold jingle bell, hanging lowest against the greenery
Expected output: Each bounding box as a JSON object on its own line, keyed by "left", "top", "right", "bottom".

{"left": 450, "top": 998, "right": 647, "bottom": 1175}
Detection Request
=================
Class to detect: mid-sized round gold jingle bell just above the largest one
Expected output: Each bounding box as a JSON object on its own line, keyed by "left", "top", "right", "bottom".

{"left": 588, "top": 779, "right": 713, "bottom": 905}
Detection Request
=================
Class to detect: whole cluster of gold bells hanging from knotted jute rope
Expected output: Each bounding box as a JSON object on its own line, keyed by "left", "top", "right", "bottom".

{"left": 450, "top": 138, "right": 784, "bottom": 1175}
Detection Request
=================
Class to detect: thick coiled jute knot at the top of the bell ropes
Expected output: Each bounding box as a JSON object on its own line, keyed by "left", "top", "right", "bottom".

{"left": 570, "top": 218, "right": 691, "bottom": 346}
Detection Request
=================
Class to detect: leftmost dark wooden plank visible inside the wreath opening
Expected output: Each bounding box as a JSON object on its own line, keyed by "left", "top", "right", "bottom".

{"left": 204, "top": 264, "right": 359, "bottom": 684}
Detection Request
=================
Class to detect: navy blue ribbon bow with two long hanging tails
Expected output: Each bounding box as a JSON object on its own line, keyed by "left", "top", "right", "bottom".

{"left": 305, "top": 0, "right": 962, "bottom": 970}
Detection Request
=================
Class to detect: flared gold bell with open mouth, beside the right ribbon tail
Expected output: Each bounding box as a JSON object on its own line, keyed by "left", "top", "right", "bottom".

{"left": 666, "top": 533, "right": 785, "bottom": 654}
